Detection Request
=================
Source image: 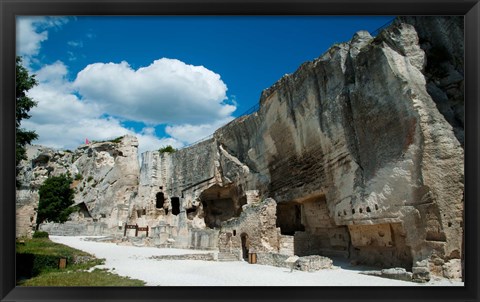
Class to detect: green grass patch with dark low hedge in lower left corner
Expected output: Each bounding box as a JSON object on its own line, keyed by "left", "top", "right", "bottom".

{"left": 16, "top": 238, "right": 145, "bottom": 286}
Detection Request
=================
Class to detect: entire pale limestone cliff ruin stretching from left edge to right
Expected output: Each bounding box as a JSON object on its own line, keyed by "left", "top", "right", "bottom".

{"left": 17, "top": 17, "right": 464, "bottom": 281}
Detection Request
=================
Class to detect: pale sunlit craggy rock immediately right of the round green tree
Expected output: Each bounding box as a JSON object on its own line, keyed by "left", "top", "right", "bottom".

{"left": 72, "top": 136, "right": 140, "bottom": 229}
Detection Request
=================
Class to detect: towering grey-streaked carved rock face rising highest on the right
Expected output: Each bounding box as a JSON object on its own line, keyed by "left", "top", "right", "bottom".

{"left": 210, "top": 18, "right": 463, "bottom": 274}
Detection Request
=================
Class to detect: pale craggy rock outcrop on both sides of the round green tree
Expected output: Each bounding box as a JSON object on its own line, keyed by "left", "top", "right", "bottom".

{"left": 17, "top": 136, "right": 140, "bottom": 236}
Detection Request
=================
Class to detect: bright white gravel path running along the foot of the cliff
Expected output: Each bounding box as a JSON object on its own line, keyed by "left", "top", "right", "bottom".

{"left": 50, "top": 236, "right": 463, "bottom": 286}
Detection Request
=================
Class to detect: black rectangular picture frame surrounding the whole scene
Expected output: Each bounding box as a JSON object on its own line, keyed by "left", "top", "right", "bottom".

{"left": 0, "top": 0, "right": 480, "bottom": 301}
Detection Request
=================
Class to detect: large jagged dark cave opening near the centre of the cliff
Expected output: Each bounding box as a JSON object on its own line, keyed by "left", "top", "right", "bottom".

{"left": 200, "top": 185, "right": 247, "bottom": 229}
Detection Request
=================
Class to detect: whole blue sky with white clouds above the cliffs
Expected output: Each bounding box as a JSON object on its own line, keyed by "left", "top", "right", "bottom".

{"left": 17, "top": 16, "right": 393, "bottom": 152}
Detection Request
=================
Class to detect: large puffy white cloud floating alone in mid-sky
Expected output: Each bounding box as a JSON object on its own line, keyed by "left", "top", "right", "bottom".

{"left": 74, "top": 58, "right": 236, "bottom": 125}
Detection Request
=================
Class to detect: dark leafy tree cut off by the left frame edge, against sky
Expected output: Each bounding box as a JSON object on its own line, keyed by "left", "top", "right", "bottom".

{"left": 15, "top": 56, "right": 38, "bottom": 180}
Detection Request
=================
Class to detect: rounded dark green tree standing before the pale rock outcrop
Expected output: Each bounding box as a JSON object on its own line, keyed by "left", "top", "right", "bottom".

{"left": 37, "top": 174, "right": 77, "bottom": 229}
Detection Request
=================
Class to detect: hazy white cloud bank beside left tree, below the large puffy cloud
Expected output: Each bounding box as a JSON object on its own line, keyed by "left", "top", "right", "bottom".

{"left": 22, "top": 61, "right": 123, "bottom": 148}
